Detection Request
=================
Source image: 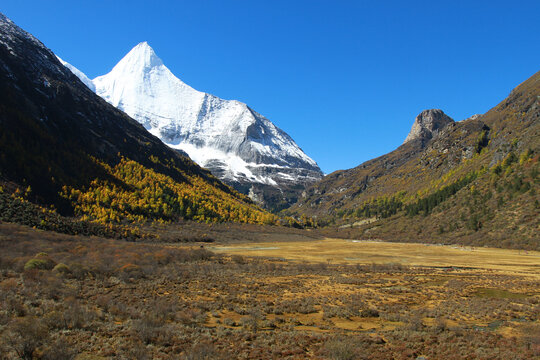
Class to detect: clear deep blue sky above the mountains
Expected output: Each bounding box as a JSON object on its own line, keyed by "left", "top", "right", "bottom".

{"left": 0, "top": 0, "right": 540, "bottom": 173}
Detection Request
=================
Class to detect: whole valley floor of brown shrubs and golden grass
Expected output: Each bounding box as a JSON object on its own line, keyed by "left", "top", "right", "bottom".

{"left": 0, "top": 223, "right": 540, "bottom": 360}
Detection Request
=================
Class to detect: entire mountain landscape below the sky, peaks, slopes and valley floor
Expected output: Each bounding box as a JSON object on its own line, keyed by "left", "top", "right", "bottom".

{"left": 0, "top": 10, "right": 540, "bottom": 360}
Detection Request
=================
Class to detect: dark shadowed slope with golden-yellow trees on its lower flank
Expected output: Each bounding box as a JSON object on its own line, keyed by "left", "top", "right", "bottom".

{"left": 0, "top": 14, "right": 275, "bottom": 231}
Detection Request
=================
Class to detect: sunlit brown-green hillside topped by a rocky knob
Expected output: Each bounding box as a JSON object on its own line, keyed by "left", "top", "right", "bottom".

{"left": 288, "top": 72, "right": 540, "bottom": 249}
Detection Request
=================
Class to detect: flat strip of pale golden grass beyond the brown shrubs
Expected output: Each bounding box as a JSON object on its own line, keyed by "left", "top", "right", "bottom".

{"left": 210, "top": 239, "right": 540, "bottom": 278}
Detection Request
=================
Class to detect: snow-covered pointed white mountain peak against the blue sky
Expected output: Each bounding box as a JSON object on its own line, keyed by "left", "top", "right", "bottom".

{"left": 66, "top": 42, "right": 322, "bottom": 210}
